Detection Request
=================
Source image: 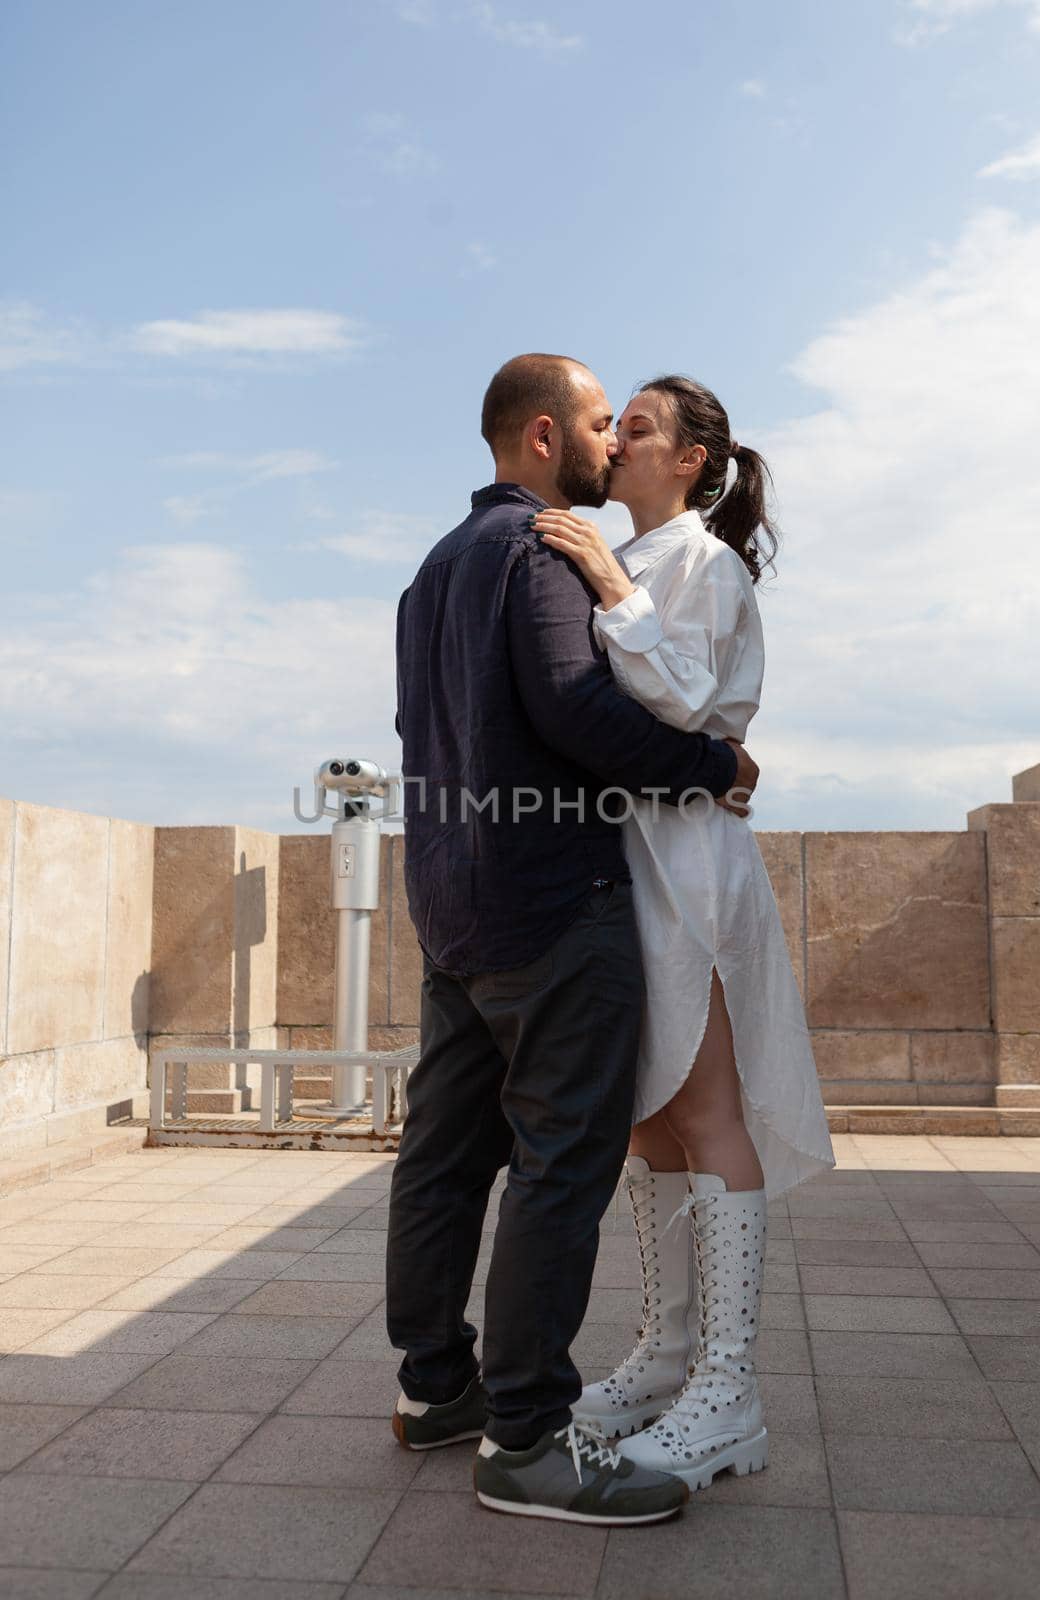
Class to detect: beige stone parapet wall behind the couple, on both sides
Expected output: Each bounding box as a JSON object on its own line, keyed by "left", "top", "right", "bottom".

{"left": 0, "top": 766, "right": 1040, "bottom": 1152}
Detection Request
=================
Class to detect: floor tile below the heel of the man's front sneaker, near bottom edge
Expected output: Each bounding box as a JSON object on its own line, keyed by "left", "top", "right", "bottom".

{"left": 353, "top": 1491, "right": 598, "bottom": 1595}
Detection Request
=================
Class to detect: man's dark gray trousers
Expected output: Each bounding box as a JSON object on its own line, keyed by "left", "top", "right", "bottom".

{"left": 380, "top": 883, "right": 643, "bottom": 1450}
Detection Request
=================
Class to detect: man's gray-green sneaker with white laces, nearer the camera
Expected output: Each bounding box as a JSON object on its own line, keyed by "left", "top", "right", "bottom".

{"left": 474, "top": 1422, "right": 690, "bottom": 1528}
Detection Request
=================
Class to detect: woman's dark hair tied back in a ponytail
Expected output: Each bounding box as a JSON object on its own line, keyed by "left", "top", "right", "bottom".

{"left": 638, "top": 373, "right": 779, "bottom": 584}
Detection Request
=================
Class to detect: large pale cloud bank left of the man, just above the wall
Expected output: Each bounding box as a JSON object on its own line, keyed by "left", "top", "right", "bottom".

{"left": 0, "top": 542, "right": 398, "bottom": 830}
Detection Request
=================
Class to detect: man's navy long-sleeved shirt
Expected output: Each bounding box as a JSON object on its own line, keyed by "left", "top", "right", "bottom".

{"left": 397, "top": 483, "right": 736, "bottom": 976}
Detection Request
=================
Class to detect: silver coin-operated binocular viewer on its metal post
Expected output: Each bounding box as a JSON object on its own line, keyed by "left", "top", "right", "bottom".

{"left": 293, "top": 757, "right": 402, "bottom": 1117}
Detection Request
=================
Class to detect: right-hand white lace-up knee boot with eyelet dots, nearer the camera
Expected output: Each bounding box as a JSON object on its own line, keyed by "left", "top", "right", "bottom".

{"left": 618, "top": 1173, "right": 770, "bottom": 1490}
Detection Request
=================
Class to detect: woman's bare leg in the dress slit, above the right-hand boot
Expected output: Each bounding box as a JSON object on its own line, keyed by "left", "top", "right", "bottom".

{"left": 665, "top": 971, "right": 763, "bottom": 1189}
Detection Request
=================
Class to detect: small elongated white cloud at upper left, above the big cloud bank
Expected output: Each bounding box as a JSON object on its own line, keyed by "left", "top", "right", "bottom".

{"left": 131, "top": 309, "right": 366, "bottom": 357}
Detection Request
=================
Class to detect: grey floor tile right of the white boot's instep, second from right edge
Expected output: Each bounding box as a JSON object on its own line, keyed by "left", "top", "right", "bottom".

{"left": 816, "top": 1376, "right": 1011, "bottom": 1438}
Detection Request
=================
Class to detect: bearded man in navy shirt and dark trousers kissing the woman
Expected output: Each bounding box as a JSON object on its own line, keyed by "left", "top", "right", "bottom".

{"left": 387, "top": 355, "right": 757, "bottom": 1523}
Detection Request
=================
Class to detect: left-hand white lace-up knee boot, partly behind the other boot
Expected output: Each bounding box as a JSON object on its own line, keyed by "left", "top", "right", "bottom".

{"left": 573, "top": 1155, "right": 699, "bottom": 1438}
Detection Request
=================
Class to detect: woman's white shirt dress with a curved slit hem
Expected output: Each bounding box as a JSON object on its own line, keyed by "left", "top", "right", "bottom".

{"left": 594, "top": 510, "right": 834, "bottom": 1197}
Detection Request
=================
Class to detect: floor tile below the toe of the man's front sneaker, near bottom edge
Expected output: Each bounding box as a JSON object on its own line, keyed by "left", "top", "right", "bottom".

{"left": 597, "top": 1497, "right": 845, "bottom": 1600}
